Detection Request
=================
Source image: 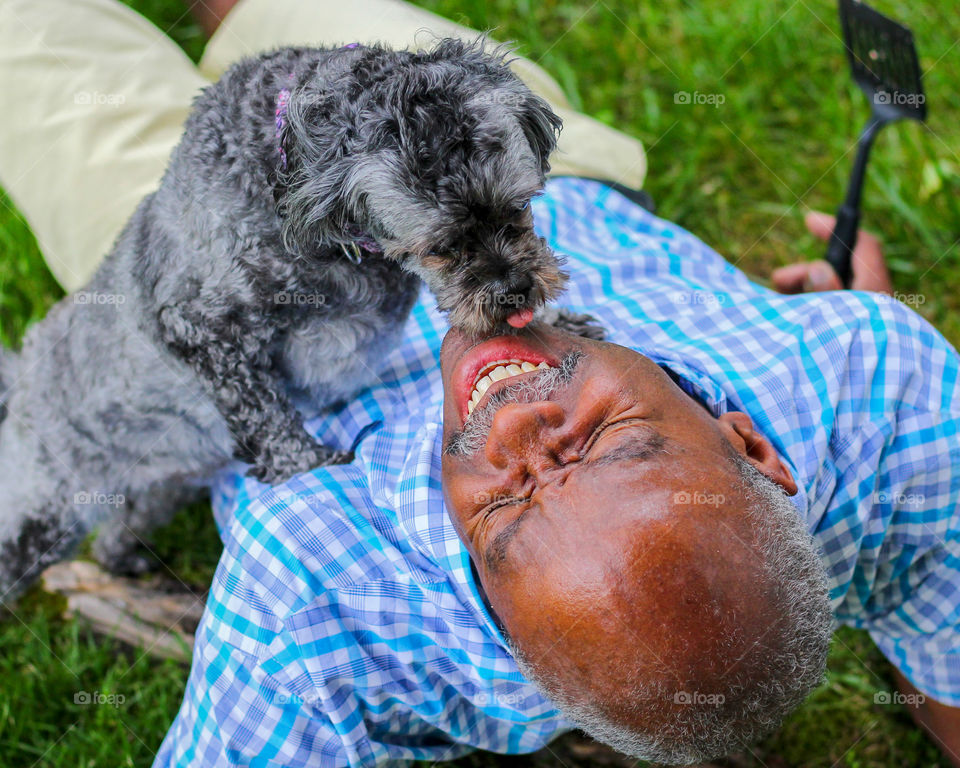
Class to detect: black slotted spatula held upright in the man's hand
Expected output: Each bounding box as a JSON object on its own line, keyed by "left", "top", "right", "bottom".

{"left": 827, "top": 0, "right": 927, "bottom": 288}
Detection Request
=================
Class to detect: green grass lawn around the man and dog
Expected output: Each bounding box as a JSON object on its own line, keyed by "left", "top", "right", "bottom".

{"left": 0, "top": 0, "right": 960, "bottom": 768}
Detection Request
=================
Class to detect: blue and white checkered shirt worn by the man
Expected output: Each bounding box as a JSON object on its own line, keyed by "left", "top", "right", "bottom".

{"left": 155, "top": 178, "right": 960, "bottom": 766}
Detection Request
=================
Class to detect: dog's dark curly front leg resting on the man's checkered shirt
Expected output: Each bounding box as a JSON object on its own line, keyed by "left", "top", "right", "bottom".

{"left": 161, "top": 307, "right": 351, "bottom": 483}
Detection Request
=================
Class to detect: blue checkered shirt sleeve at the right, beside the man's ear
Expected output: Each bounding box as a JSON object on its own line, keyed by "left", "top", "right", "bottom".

{"left": 818, "top": 292, "right": 960, "bottom": 706}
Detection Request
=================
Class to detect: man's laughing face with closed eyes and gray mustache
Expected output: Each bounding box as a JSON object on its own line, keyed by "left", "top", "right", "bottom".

{"left": 441, "top": 324, "right": 796, "bottom": 680}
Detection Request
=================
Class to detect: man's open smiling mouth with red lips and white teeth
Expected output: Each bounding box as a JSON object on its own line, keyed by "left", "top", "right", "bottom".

{"left": 453, "top": 336, "right": 557, "bottom": 425}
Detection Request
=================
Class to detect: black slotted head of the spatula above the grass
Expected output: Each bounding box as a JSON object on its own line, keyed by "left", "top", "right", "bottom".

{"left": 840, "top": 0, "right": 927, "bottom": 121}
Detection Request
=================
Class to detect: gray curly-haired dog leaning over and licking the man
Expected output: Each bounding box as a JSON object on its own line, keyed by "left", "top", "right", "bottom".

{"left": 0, "top": 39, "right": 589, "bottom": 601}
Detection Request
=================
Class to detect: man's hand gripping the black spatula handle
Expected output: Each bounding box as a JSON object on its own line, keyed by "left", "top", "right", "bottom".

{"left": 771, "top": 211, "right": 893, "bottom": 295}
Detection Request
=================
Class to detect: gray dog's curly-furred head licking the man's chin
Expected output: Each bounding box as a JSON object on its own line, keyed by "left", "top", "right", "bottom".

{"left": 274, "top": 38, "right": 566, "bottom": 333}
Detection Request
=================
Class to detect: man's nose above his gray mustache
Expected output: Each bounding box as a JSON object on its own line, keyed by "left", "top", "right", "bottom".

{"left": 485, "top": 400, "right": 566, "bottom": 474}
